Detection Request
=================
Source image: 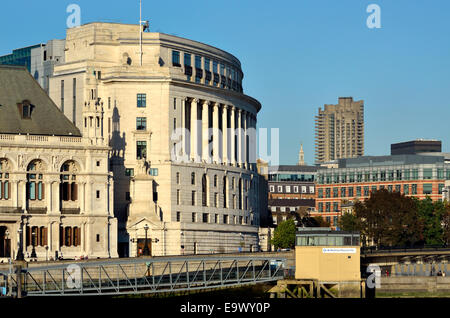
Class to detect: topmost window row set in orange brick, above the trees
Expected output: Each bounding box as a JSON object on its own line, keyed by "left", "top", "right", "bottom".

{"left": 317, "top": 183, "right": 445, "bottom": 198}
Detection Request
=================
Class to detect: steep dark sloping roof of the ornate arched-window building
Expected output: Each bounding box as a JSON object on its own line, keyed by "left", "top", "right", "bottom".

{"left": 0, "top": 65, "right": 81, "bottom": 137}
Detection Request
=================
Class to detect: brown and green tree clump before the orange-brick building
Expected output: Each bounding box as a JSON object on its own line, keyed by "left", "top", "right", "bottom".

{"left": 356, "top": 189, "right": 450, "bottom": 246}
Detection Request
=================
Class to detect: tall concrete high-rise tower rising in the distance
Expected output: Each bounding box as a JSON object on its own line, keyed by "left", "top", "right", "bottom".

{"left": 315, "top": 97, "right": 364, "bottom": 164}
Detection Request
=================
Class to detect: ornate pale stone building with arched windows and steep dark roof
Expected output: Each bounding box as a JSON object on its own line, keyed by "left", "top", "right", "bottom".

{"left": 0, "top": 66, "right": 118, "bottom": 262}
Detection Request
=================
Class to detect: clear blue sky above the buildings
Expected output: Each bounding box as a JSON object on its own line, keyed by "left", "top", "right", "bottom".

{"left": 0, "top": 0, "right": 450, "bottom": 164}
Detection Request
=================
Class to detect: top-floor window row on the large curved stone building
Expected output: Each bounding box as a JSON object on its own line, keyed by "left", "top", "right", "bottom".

{"left": 172, "top": 50, "right": 243, "bottom": 93}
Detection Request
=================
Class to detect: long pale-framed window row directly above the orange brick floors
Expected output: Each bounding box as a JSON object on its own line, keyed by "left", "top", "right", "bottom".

{"left": 318, "top": 168, "right": 450, "bottom": 184}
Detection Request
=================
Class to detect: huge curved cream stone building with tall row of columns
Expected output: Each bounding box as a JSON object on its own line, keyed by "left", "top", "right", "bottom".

{"left": 50, "top": 23, "right": 267, "bottom": 256}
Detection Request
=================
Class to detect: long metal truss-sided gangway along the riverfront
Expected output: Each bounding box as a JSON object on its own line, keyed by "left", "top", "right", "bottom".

{"left": 0, "top": 257, "right": 284, "bottom": 296}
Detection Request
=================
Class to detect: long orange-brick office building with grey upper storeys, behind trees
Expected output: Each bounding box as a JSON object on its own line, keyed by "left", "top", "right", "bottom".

{"left": 312, "top": 154, "right": 450, "bottom": 227}
